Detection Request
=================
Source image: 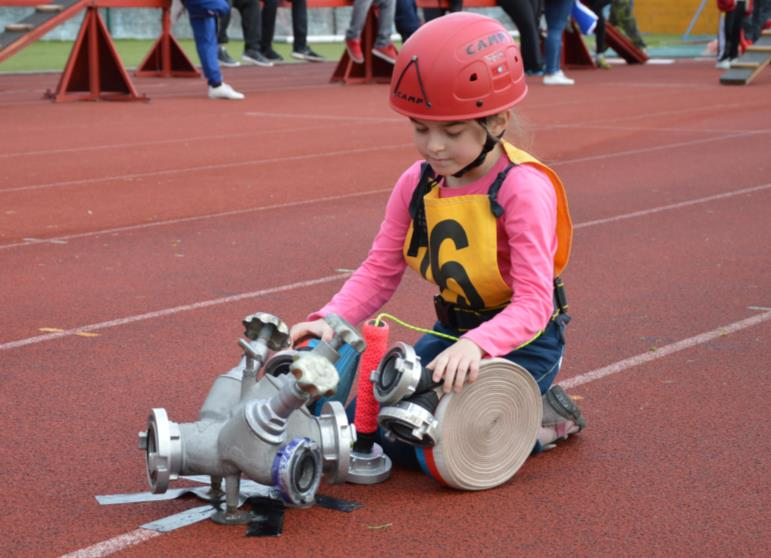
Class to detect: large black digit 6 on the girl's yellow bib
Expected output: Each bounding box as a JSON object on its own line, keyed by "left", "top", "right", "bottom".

{"left": 420, "top": 219, "right": 485, "bottom": 308}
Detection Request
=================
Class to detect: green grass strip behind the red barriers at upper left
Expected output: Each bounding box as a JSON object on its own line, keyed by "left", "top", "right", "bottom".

{"left": 0, "top": 39, "right": 343, "bottom": 73}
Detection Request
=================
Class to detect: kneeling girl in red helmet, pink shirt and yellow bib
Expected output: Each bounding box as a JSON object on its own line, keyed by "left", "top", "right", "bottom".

{"left": 291, "top": 12, "right": 585, "bottom": 466}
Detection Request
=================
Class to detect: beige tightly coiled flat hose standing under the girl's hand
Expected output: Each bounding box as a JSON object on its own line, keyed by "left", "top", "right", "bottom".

{"left": 415, "top": 358, "right": 543, "bottom": 490}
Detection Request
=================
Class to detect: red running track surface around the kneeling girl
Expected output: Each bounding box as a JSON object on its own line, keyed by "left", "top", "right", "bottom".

{"left": 0, "top": 62, "right": 771, "bottom": 557}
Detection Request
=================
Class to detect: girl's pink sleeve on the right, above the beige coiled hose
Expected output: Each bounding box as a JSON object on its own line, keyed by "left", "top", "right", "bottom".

{"left": 463, "top": 165, "right": 557, "bottom": 357}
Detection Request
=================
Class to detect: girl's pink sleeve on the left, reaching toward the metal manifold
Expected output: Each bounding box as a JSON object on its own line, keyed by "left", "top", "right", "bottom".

{"left": 308, "top": 162, "right": 420, "bottom": 324}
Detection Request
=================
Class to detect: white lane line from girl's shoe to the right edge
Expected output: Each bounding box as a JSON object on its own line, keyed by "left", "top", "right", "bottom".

{"left": 559, "top": 312, "right": 771, "bottom": 389}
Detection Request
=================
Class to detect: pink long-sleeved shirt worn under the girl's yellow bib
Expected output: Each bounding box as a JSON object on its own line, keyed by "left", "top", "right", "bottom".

{"left": 309, "top": 156, "right": 557, "bottom": 357}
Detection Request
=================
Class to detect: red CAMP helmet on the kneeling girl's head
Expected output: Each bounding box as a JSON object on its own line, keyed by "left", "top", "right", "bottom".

{"left": 389, "top": 12, "right": 527, "bottom": 120}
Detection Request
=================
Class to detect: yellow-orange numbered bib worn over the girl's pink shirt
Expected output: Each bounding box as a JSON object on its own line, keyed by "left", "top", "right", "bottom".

{"left": 403, "top": 141, "right": 573, "bottom": 310}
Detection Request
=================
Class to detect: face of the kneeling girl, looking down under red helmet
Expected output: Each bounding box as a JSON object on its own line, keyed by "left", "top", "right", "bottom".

{"left": 410, "top": 115, "right": 508, "bottom": 186}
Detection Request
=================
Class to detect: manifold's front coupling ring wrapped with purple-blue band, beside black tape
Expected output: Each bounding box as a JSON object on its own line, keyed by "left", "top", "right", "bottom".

{"left": 271, "top": 438, "right": 321, "bottom": 506}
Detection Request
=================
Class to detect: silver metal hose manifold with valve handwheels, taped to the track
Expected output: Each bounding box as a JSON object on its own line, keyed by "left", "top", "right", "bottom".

{"left": 139, "top": 313, "right": 364, "bottom": 523}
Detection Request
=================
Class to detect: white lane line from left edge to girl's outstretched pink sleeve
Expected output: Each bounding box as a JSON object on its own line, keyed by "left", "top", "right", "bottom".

{"left": 0, "top": 273, "right": 351, "bottom": 351}
